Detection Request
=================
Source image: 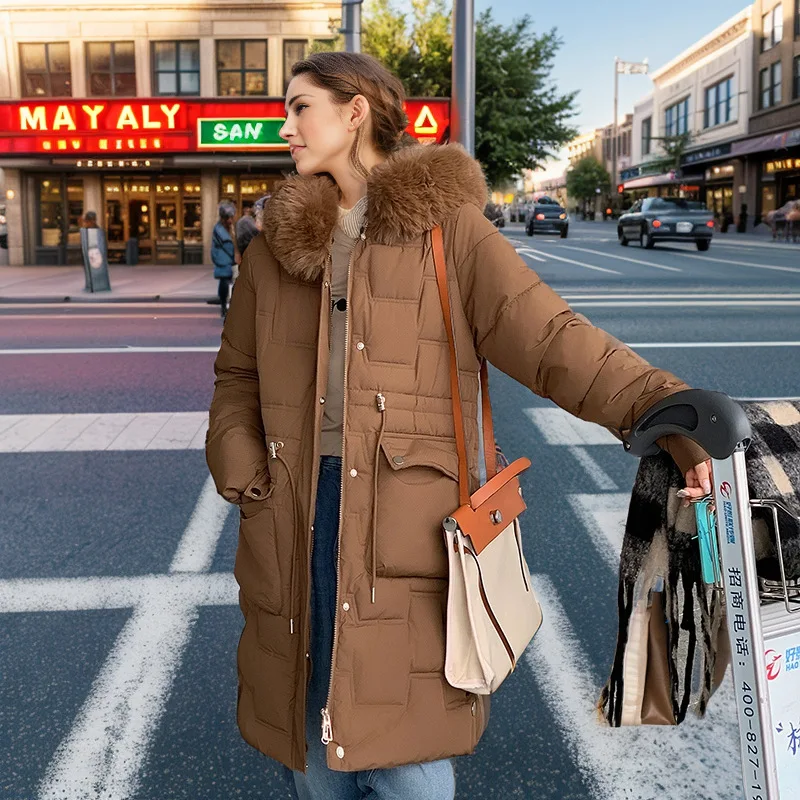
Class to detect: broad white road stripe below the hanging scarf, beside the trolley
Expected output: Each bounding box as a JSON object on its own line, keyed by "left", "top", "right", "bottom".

{"left": 524, "top": 575, "right": 742, "bottom": 800}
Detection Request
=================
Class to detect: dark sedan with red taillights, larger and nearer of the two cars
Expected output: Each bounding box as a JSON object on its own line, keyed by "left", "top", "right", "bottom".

{"left": 617, "top": 197, "right": 714, "bottom": 250}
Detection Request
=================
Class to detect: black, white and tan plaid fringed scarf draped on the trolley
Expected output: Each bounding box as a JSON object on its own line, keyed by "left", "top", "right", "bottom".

{"left": 599, "top": 401, "right": 800, "bottom": 727}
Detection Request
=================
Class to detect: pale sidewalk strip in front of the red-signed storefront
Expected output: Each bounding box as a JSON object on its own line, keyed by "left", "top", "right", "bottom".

{"left": 0, "top": 265, "right": 217, "bottom": 304}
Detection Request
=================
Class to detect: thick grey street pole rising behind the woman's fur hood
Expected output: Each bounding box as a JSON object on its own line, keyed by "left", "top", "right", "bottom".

{"left": 450, "top": 0, "right": 475, "bottom": 156}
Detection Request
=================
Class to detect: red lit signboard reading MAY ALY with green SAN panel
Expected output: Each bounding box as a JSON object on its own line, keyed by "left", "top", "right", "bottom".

{"left": 0, "top": 97, "right": 450, "bottom": 157}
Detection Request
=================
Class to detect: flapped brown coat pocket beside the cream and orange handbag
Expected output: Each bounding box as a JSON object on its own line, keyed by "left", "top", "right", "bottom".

{"left": 376, "top": 435, "right": 458, "bottom": 578}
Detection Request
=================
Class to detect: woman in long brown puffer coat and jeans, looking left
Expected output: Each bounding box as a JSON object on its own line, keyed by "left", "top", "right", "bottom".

{"left": 206, "top": 53, "right": 709, "bottom": 800}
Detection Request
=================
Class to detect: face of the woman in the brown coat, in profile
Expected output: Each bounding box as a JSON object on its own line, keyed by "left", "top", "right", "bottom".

{"left": 280, "top": 75, "right": 363, "bottom": 175}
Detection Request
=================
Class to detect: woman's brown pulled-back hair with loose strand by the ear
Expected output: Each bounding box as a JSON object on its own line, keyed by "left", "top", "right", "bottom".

{"left": 292, "top": 52, "right": 416, "bottom": 178}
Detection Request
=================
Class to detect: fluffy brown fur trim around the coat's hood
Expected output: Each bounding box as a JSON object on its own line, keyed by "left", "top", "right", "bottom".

{"left": 263, "top": 144, "right": 488, "bottom": 281}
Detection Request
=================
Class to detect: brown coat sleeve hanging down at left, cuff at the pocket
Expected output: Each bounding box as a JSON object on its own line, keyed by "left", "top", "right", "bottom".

{"left": 206, "top": 247, "right": 270, "bottom": 503}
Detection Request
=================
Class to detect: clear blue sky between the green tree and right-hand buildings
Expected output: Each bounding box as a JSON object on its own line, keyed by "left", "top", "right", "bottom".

{"left": 475, "top": 0, "right": 748, "bottom": 131}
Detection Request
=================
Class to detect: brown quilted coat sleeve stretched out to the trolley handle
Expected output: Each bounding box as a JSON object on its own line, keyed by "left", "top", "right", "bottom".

{"left": 445, "top": 206, "right": 708, "bottom": 474}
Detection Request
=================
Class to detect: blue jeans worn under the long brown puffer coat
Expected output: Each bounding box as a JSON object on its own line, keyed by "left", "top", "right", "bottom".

{"left": 293, "top": 456, "right": 456, "bottom": 800}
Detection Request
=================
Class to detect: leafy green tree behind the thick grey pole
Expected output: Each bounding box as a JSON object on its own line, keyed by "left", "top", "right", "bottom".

{"left": 362, "top": 0, "right": 577, "bottom": 186}
